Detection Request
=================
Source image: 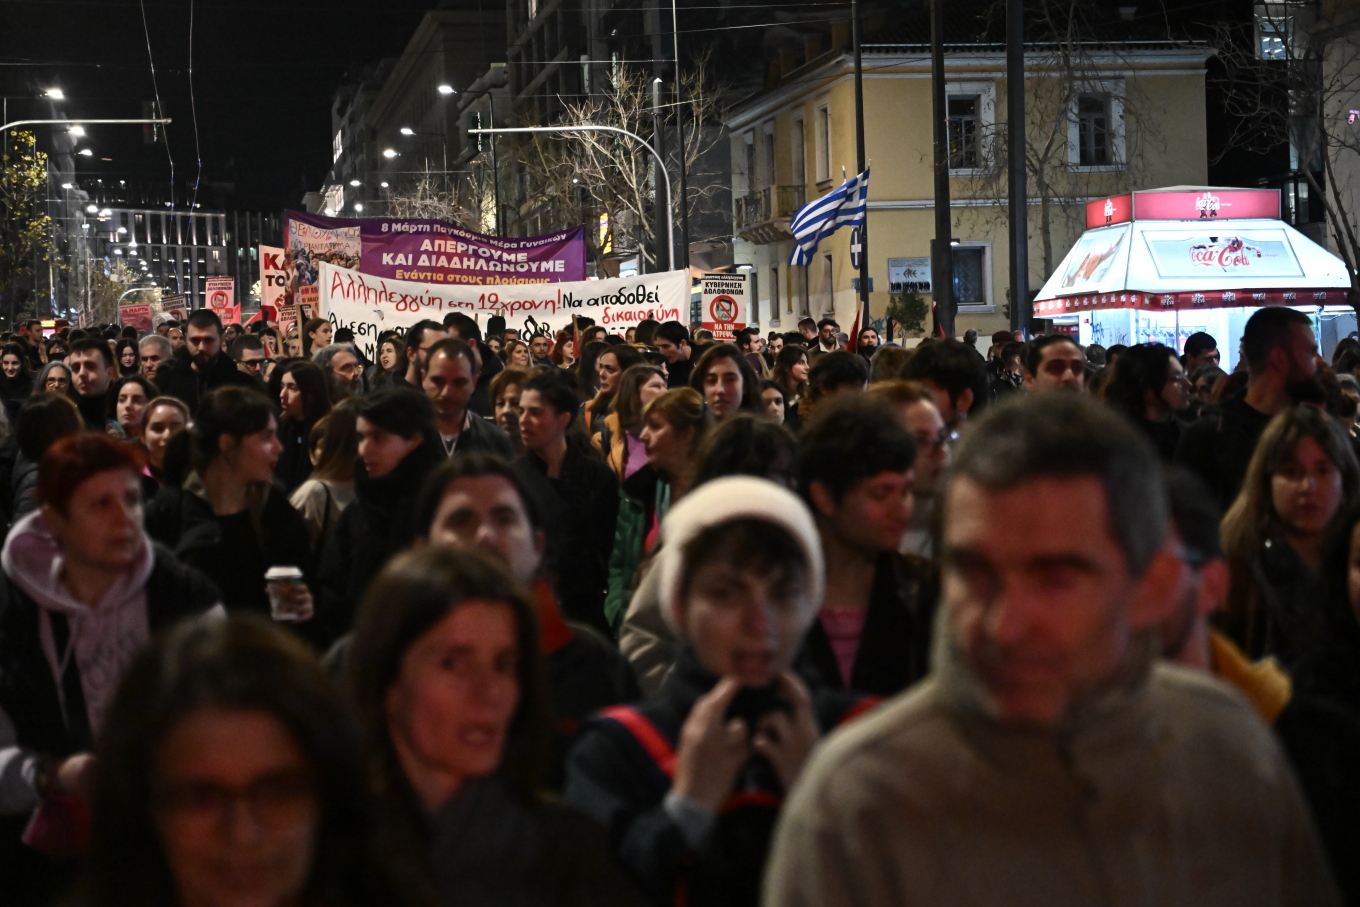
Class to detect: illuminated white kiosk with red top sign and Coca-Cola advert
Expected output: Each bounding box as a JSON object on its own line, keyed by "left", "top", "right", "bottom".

{"left": 1034, "top": 186, "right": 1356, "bottom": 369}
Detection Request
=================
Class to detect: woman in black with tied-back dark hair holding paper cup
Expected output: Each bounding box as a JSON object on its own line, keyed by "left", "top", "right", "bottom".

{"left": 147, "top": 386, "right": 313, "bottom": 621}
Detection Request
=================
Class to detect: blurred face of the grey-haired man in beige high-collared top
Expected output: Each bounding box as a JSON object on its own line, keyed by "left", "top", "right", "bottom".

{"left": 941, "top": 476, "right": 1179, "bottom": 729}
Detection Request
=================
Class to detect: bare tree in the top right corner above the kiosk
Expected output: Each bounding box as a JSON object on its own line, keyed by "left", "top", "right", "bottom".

{"left": 1213, "top": 1, "right": 1360, "bottom": 303}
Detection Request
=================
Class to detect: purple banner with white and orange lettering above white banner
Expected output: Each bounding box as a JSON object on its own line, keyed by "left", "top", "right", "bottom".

{"left": 284, "top": 211, "right": 586, "bottom": 295}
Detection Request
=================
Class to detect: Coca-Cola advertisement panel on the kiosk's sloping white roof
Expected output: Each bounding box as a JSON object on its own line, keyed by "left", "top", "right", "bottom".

{"left": 1142, "top": 228, "right": 1303, "bottom": 278}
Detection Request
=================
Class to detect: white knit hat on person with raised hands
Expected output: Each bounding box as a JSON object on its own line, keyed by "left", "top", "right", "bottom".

{"left": 656, "top": 476, "right": 826, "bottom": 635}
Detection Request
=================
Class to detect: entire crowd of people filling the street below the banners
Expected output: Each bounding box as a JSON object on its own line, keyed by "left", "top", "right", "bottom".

{"left": 0, "top": 307, "right": 1360, "bottom": 907}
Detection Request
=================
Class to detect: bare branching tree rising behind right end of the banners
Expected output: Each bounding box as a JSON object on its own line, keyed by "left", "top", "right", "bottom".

{"left": 520, "top": 58, "right": 722, "bottom": 265}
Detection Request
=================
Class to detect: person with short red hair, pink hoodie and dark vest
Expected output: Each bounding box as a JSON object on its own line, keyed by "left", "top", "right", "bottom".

{"left": 0, "top": 435, "right": 220, "bottom": 904}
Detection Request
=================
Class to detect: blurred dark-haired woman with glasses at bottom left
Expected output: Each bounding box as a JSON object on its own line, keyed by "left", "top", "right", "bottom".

{"left": 82, "top": 617, "right": 411, "bottom": 907}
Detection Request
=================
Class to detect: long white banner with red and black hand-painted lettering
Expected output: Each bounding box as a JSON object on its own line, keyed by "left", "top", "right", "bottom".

{"left": 317, "top": 261, "right": 690, "bottom": 359}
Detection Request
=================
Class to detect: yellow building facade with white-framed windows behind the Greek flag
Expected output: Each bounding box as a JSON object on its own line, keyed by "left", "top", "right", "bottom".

{"left": 726, "top": 45, "right": 1208, "bottom": 336}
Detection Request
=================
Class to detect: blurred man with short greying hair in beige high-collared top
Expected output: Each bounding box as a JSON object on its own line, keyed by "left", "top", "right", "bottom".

{"left": 764, "top": 394, "right": 1340, "bottom": 907}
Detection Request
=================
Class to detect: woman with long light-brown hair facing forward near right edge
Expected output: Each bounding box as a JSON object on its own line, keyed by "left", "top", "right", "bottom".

{"left": 1224, "top": 407, "right": 1360, "bottom": 668}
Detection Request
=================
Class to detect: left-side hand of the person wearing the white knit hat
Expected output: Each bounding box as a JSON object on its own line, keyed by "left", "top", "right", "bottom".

{"left": 675, "top": 677, "right": 751, "bottom": 813}
